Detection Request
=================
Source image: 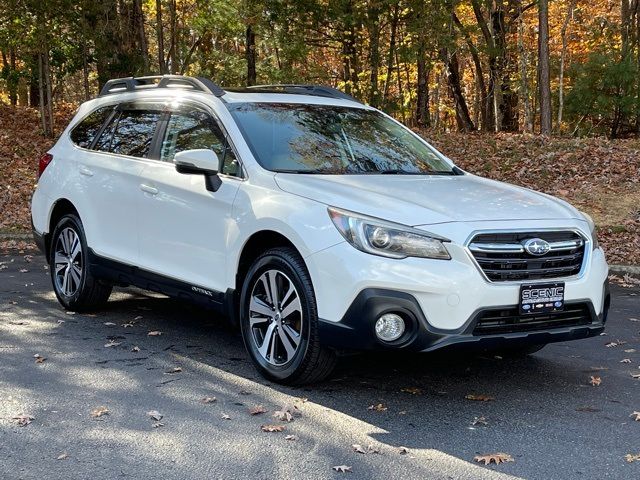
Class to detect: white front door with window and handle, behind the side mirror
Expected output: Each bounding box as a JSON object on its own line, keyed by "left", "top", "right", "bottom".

{"left": 138, "top": 104, "right": 241, "bottom": 297}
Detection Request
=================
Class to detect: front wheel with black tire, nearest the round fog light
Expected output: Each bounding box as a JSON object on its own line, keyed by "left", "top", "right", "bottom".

{"left": 240, "top": 247, "right": 337, "bottom": 385}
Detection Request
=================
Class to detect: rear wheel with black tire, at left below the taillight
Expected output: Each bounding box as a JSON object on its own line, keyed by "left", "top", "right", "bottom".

{"left": 49, "top": 214, "right": 112, "bottom": 312}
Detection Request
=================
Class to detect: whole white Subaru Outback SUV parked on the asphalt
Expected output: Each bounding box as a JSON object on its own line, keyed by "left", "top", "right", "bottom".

{"left": 32, "top": 76, "right": 609, "bottom": 383}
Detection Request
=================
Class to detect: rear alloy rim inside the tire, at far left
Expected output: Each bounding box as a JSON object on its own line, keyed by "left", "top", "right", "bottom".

{"left": 53, "top": 227, "right": 83, "bottom": 297}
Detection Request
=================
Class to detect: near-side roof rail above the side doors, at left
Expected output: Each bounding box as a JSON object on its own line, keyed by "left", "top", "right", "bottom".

{"left": 99, "top": 75, "right": 225, "bottom": 97}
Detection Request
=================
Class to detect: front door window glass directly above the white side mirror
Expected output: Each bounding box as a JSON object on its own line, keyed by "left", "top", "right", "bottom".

{"left": 160, "top": 110, "right": 239, "bottom": 175}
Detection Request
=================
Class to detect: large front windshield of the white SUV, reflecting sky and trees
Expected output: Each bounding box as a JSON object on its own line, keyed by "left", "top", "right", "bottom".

{"left": 228, "top": 103, "right": 455, "bottom": 175}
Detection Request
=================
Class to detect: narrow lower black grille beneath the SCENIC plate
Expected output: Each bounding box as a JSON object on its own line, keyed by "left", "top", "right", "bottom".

{"left": 473, "top": 303, "right": 592, "bottom": 335}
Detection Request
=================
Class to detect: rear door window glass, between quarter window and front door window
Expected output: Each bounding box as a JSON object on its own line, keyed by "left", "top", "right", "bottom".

{"left": 96, "top": 110, "right": 161, "bottom": 158}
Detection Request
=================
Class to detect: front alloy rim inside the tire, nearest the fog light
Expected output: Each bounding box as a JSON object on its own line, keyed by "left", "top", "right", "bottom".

{"left": 249, "top": 269, "right": 304, "bottom": 366}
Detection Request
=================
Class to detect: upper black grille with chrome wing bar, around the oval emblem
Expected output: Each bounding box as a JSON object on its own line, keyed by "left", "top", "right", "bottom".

{"left": 469, "top": 231, "right": 585, "bottom": 282}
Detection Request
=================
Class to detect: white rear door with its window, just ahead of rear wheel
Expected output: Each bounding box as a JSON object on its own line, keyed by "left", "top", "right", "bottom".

{"left": 77, "top": 104, "right": 162, "bottom": 265}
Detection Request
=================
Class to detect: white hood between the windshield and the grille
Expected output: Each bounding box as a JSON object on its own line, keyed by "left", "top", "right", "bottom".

{"left": 275, "top": 173, "right": 581, "bottom": 226}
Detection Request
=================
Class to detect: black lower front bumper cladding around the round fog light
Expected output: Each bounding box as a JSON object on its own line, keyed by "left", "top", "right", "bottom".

{"left": 319, "top": 283, "right": 610, "bottom": 352}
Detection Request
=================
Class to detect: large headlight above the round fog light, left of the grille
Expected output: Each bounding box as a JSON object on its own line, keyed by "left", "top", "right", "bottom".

{"left": 328, "top": 207, "right": 451, "bottom": 260}
